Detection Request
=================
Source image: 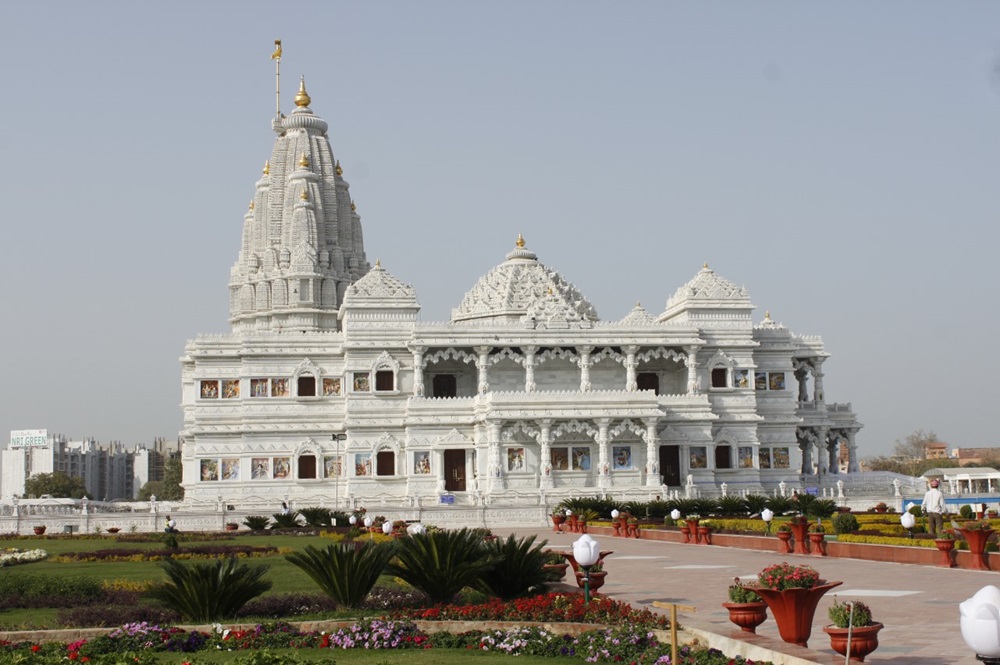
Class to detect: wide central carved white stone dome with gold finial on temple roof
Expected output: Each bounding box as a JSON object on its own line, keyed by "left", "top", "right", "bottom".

{"left": 451, "top": 236, "right": 598, "bottom": 327}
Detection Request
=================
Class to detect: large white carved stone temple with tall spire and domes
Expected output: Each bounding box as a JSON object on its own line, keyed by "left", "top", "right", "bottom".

{"left": 181, "top": 82, "right": 861, "bottom": 508}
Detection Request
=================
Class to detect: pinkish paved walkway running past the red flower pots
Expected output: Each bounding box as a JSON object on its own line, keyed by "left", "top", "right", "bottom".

{"left": 516, "top": 529, "right": 988, "bottom": 665}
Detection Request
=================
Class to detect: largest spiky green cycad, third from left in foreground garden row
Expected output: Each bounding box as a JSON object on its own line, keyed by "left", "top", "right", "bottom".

{"left": 386, "top": 529, "right": 497, "bottom": 603}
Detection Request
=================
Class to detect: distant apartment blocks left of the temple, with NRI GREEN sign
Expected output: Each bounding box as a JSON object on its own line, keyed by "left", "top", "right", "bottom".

{"left": 0, "top": 430, "right": 180, "bottom": 500}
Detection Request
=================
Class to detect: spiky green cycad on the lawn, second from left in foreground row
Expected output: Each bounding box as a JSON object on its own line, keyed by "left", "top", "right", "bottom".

{"left": 285, "top": 543, "right": 395, "bottom": 607}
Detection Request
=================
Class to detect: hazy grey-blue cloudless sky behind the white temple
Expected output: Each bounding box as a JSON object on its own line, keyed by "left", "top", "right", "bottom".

{"left": 0, "top": 0, "right": 1000, "bottom": 456}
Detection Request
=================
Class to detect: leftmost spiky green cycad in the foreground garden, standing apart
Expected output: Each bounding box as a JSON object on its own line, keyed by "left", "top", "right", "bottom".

{"left": 150, "top": 557, "right": 271, "bottom": 623}
